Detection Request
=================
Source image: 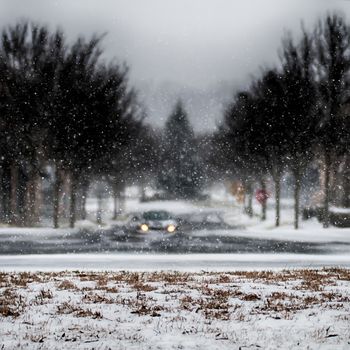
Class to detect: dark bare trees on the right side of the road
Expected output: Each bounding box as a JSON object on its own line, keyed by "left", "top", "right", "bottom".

{"left": 212, "top": 14, "right": 350, "bottom": 228}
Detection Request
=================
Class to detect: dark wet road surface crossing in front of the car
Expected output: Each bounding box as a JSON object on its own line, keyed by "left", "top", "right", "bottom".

{"left": 0, "top": 227, "right": 350, "bottom": 255}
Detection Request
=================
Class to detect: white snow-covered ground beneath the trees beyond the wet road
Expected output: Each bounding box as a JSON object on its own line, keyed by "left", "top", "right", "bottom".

{"left": 0, "top": 191, "right": 350, "bottom": 243}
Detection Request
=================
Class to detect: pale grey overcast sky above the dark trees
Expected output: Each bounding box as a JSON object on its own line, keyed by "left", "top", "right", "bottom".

{"left": 0, "top": 0, "right": 350, "bottom": 130}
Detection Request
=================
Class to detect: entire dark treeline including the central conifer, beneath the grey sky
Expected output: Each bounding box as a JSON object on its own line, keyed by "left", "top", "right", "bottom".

{"left": 0, "top": 14, "right": 350, "bottom": 228}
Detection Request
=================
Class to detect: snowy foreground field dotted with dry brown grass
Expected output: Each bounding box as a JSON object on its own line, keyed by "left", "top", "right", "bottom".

{"left": 0, "top": 268, "right": 350, "bottom": 350}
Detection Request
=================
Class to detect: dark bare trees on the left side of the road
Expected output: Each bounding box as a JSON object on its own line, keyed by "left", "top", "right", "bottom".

{"left": 0, "top": 22, "right": 159, "bottom": 227}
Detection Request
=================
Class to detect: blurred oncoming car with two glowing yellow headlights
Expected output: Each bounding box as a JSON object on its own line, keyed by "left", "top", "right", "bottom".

{"left": 128, "top": 210, "right": 178, "bottom": 233}
